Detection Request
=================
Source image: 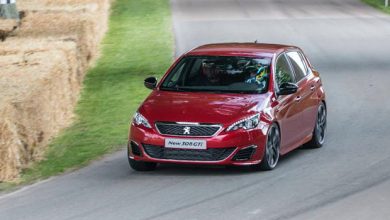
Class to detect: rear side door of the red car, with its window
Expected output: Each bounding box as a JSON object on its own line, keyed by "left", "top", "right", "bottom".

{"left": 286, "top": 51, "right": 318, "bottom": 140}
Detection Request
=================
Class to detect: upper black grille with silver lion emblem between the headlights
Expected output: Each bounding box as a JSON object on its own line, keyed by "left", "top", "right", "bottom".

{"left": 156, "top": 122, "right": 221, "bottom": 137}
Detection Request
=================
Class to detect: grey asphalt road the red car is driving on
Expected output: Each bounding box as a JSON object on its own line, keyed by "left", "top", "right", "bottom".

{"left": 0, "top": 0, "right": 390, "bottom": 220}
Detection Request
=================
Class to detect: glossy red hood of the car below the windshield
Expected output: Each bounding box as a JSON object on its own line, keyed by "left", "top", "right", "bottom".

{"left": 139, "top": 90, "right": 269, "bottom": 125}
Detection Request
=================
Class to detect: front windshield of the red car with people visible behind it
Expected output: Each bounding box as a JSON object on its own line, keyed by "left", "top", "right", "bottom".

{"left": 160, "top": 56, "right": 271, "bottom": 94}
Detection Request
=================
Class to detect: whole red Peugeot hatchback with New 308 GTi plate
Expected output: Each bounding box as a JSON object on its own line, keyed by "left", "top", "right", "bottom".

{"left": 128, "top": 43, "right": 327, "bottom": 171}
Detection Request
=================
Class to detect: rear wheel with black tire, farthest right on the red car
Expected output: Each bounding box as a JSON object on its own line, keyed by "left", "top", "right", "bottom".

{"left": 305, "top": 102, "right": 327, "bottom": 148}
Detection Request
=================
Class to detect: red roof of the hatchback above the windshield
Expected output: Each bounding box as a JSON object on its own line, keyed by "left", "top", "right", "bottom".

{"left": 186, "top": 43, "right": 295, "bottom": 57}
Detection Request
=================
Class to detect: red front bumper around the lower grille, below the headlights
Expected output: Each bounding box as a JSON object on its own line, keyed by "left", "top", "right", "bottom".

{"left": 128, "top": 125, "right": 268, "bottom": 165}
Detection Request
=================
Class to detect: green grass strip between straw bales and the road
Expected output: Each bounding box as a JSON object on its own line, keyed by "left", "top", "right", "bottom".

{"left": 0, "top": 0, "right": 173, "bottom": 190}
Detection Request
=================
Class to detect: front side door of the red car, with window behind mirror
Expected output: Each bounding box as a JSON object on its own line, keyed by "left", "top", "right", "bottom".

{"left": 274, "top": 53, "right": 302, "bottom": 154}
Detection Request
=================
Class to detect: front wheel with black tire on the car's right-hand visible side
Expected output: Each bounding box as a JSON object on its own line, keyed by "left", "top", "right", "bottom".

{"left": 254, "top": 124, "right": 280, "bottom": 170}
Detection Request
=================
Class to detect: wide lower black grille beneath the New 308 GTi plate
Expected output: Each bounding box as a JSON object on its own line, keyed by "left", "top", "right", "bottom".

{"left": 143, "top": 144, "right": 235, "bottom": 161}
